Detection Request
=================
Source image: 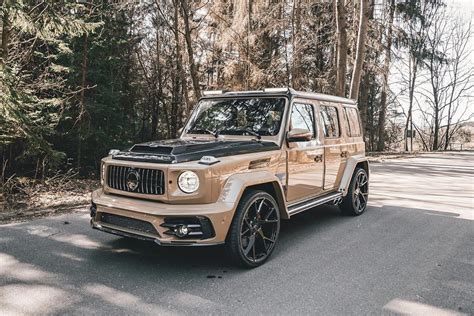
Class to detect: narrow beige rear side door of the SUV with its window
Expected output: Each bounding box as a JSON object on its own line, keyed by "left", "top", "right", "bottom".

{"left": 320, "top": 102, "right": 348, "bottom": 190}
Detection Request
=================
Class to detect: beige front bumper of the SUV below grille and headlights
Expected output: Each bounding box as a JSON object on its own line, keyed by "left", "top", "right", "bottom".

{"left": 91, "top": 189, "right": 235, "bottom": 246}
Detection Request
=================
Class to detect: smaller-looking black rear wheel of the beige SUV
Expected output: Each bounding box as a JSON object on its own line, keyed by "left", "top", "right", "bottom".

{"left": 339, "top": 168, "right": 369, "bottom": 216}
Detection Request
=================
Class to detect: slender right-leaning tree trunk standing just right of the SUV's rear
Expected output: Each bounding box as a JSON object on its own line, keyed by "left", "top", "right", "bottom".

{"left": 377, "top": 0, "right": 395, "bottom": 151}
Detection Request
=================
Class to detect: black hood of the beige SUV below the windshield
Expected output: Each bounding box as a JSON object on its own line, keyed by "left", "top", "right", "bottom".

{"left": 112, "top": 139, "right": 280, "bottom": 163}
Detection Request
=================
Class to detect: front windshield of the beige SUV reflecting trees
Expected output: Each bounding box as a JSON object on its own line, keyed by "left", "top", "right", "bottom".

{"left": 185, "top": 98, "right": 285, "bottom": 136}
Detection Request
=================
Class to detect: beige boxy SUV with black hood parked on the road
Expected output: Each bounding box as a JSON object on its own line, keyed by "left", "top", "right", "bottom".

{"left": 91, "top": 88, "right": 369, "bottom": 267}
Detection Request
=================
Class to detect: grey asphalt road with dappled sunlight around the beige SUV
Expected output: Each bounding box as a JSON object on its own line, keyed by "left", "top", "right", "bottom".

{"left": 0, "top": 153, "right": 474, "bottom": 315}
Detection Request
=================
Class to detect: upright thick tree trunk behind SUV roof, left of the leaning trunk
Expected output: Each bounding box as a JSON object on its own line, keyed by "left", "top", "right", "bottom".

{"left": 334, "top": 0, "right": 347, "bottom": 97}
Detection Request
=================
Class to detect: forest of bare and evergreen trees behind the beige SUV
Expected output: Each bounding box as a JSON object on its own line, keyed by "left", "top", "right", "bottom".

{"left": 0, "top": 0, "right": 474, "bottom": 195}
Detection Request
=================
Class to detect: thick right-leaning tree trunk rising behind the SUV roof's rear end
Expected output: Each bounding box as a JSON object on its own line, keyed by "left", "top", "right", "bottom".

{"left": 349, "top": 0, "right": 369, "bottom": 100}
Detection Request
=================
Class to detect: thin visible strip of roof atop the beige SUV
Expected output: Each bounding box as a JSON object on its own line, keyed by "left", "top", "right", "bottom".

{"left": 198, "top": 88, "right": 357, "bottom": 106}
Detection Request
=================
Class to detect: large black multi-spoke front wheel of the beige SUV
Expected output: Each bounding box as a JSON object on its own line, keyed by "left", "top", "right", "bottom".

{"left": 226, "top": 191, "right": 280, "bottom": 268}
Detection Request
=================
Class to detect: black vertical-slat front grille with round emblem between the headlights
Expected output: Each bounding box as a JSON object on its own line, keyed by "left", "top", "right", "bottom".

{"left": 107, "top": 166, "right": 165, "bottom": 195}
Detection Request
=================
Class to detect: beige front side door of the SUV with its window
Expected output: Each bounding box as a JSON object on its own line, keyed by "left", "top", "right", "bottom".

{"left": 286, "top": 100, "right": 324, "bottom": 203}
